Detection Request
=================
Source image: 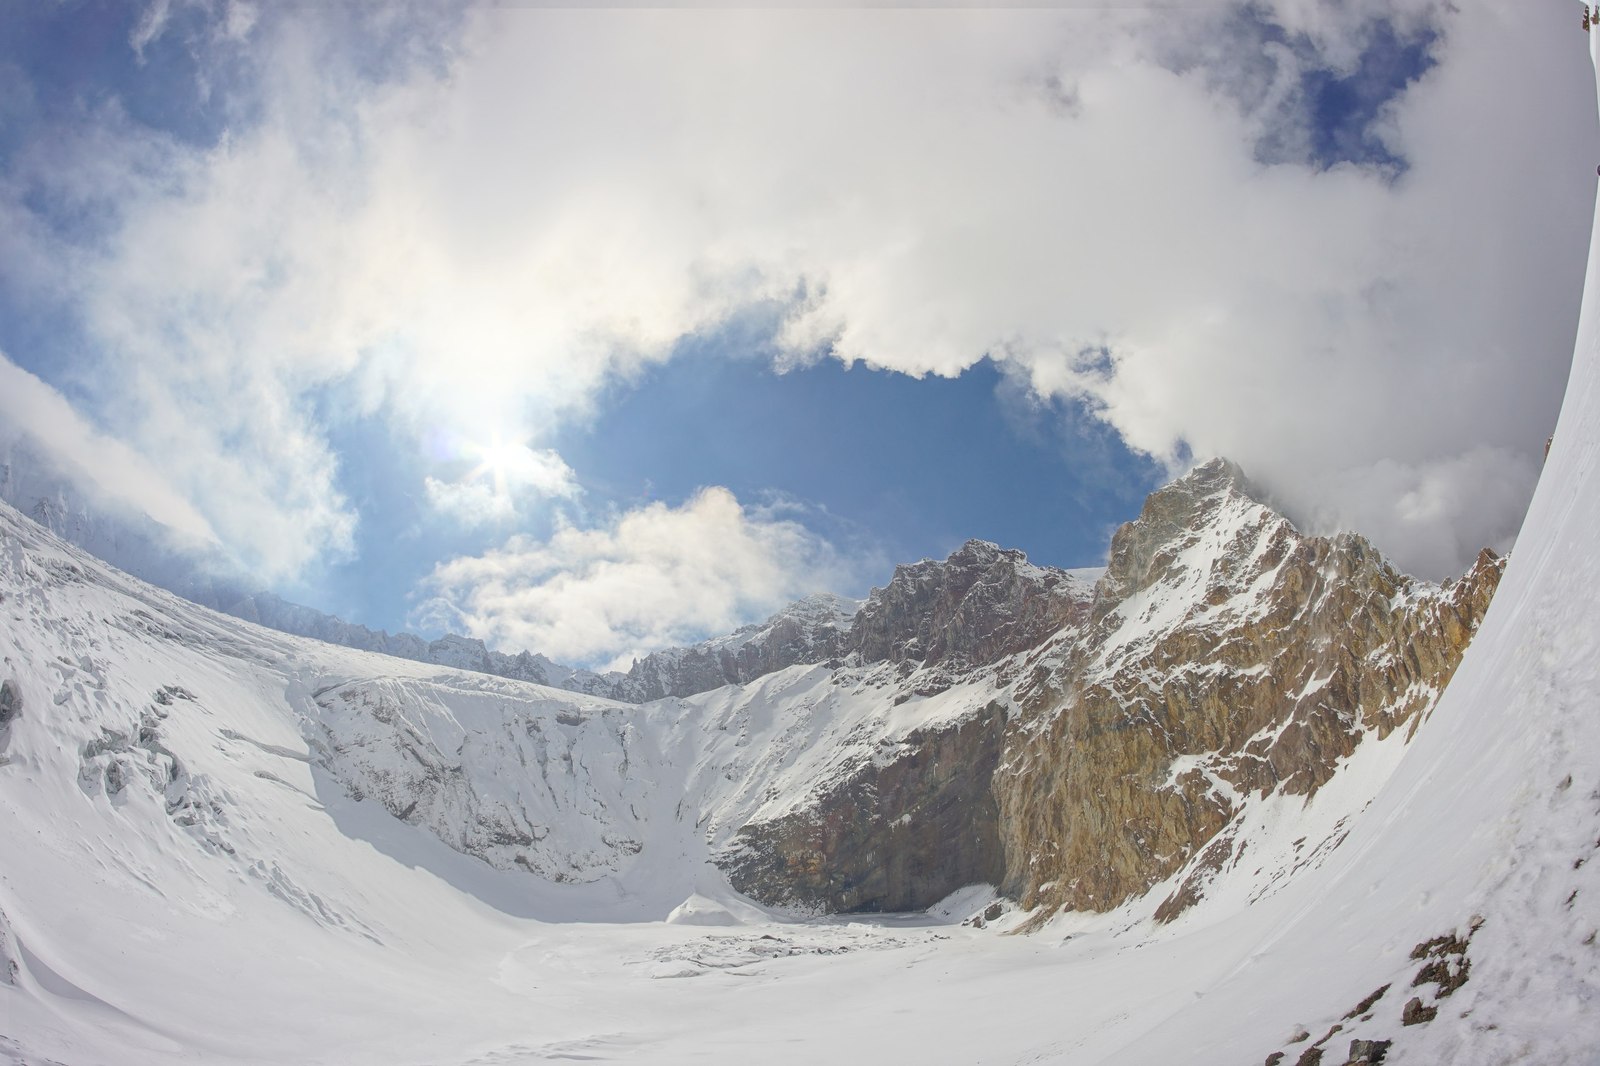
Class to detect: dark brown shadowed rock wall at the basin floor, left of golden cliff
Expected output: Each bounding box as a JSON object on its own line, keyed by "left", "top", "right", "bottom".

{"left": 718, "top": 704, "right": 1005, "bottom": 912}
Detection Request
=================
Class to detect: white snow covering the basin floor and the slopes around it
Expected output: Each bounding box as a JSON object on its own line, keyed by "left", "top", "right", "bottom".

{"left": 0, "top": 35, "right": 1600, "bottom": 1066}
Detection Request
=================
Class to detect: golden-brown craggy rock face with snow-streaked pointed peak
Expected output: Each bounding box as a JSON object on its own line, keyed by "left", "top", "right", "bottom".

{"left": 994, "top": 461, "right": 1502, "bottom": 917}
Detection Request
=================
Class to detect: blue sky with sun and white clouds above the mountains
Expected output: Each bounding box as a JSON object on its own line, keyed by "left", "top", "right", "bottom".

{"left": 0, "top": 0, "right": 1600, "bottom": 666}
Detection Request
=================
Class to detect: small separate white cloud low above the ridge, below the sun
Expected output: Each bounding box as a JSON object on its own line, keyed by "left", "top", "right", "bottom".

{"left": 418, "top": 488, "right": 856, "bottom": 669}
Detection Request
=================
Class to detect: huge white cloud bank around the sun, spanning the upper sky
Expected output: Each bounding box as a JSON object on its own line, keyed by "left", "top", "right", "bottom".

{"left": 0, "top": 0, "right": 1595, "bottom": 598}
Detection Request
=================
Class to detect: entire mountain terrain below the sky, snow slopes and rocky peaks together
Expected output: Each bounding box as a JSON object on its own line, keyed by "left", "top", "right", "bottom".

{"left": 9, "top": 37, "right": 1600, "bottom": 1066}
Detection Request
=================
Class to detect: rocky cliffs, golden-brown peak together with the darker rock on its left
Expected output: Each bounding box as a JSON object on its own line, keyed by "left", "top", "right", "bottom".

{"left": 722, "top": 461, "right": 1502, "bottom": 917}
